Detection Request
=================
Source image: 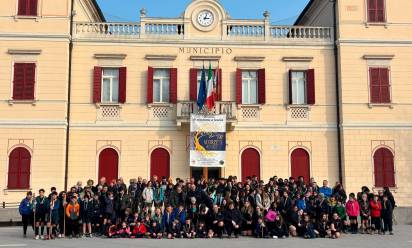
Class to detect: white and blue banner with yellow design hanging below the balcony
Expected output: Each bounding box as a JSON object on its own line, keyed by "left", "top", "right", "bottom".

{"left": 190, "top": 115, "right": 226, "bottom": 167}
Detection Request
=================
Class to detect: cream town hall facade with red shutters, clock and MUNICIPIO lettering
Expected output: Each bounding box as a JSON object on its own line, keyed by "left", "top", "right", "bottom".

{"left": 0, "top": 0, "right": 412, "bottom": 206}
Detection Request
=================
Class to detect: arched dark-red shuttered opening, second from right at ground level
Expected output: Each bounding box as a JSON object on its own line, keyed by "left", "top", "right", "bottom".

{"left": 290, "top": 148, "right": 310, "bottom": 183}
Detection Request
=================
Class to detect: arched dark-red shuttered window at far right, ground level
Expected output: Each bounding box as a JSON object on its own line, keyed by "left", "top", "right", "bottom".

{"left": 373, "top": 148, "right": 395, "bottom": 187}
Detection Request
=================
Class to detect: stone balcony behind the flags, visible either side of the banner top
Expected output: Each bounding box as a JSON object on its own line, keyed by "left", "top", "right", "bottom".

{"left": 176, "top": 101, "right": 237, "bottom": 126}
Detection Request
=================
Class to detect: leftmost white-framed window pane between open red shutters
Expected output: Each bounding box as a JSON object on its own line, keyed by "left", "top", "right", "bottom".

{"left": 102, "top": 68, "right": 119, "bottom": 103}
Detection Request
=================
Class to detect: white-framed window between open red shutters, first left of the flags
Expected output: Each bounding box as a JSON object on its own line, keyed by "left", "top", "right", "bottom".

{"left": 153, "top": 69, "right": 170, "bottom": 103}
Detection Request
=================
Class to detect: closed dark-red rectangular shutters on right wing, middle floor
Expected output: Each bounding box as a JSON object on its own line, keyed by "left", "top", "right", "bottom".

{"left": 369, "top": 67, "right": 391, "bottom": 104}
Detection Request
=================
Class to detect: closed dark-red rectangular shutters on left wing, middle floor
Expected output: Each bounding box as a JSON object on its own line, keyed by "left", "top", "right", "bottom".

{"left": 13, "top": 63, "right": 36, "bottom": 100}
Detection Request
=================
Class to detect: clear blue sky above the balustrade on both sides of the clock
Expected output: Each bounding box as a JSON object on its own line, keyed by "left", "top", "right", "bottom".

{"left": 97, "top": 0, "right": 309, "bottom": 25}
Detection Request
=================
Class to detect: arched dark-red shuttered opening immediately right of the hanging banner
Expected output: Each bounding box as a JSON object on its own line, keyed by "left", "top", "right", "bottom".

{"left": 241, "top": 148, "right": 260, "bottom": 182}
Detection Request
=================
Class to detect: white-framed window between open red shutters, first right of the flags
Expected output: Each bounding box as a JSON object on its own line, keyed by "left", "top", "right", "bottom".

{"left": 242, "top": 71, "right": 258, "bottom": 104}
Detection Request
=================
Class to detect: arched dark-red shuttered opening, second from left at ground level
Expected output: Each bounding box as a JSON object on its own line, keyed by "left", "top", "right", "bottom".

{"left": 98, "top": 148, "right": 119, "bottom": 183}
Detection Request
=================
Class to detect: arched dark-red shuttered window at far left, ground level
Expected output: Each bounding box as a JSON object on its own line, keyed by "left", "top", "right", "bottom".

{"left": 7, "top": 147, "right": 31, "bottom": 189}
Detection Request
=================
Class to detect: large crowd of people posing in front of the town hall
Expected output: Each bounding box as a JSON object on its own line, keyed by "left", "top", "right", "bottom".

{"left": 19, "top": 176, "right": 396, "bottom": 239}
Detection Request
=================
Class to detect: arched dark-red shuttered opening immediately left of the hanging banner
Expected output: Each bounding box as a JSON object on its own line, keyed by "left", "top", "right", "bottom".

{"left": 150, "top": 148, "right": 170, "bottom": 179}
